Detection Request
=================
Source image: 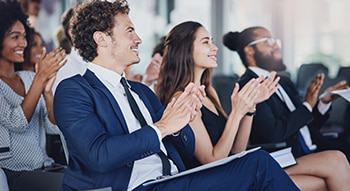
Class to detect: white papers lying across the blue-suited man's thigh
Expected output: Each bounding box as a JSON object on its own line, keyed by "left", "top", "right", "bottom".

{"left": 143, "top": 147, "right": 261, "bottom": 186}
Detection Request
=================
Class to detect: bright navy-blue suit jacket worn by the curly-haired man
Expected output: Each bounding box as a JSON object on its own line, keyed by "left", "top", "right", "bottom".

{"left": 54, "top": 70, "right": 195, "bottom": 190}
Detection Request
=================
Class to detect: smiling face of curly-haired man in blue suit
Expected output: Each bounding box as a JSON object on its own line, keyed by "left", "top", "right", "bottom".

{"left": 111, "top": 13, "right": 142, "bottom": 67}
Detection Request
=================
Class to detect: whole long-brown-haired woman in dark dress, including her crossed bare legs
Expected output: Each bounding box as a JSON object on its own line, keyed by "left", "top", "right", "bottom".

{"left": 156, "top": 22, "right": 350, "bottom": 191}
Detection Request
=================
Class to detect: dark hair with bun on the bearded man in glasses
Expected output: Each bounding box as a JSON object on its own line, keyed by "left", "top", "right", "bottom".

{"left": 222, "top": 27, "right": 263, "bottom": 67}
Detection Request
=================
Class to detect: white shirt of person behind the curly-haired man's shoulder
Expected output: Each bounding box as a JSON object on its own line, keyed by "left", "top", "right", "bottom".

{"left": 52, "top": 47, "right": 88, "bottom": 95}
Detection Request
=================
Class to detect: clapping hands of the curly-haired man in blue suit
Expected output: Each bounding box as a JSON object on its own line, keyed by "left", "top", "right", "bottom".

{"left": 154, "top": 83, "right": 204, "bottom": 137}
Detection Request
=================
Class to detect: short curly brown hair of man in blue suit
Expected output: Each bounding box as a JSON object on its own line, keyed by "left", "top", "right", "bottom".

{"left": 70, "top": 0, "right": 129, "bottom": 61}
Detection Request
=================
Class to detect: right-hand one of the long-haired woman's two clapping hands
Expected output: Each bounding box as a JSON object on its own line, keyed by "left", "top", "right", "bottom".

{"left": 255, "top": 71, "right": 280, "bottom": 104}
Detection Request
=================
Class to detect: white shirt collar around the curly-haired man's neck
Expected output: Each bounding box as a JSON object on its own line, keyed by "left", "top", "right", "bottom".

{"left": 87, "top": 62, "right": 125, "bottom": 88}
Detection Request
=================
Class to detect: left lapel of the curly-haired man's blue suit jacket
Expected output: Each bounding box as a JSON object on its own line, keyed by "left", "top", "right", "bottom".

{"left": 83, "top": 70, "right": 129, "bottom": 134}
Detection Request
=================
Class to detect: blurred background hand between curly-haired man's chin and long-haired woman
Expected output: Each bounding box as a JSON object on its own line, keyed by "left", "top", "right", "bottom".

{"left": 143, "top": 53, "right": 163, "bottom": 86}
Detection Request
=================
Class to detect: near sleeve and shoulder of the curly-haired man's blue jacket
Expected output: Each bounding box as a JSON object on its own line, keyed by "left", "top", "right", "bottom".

{"left": 54, "top": 78, "right": 167, "bottom": 173}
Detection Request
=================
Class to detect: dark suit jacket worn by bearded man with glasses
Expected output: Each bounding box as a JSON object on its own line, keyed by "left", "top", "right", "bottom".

{"left": 238, "top": 69, "right": 329, "bottom": 157}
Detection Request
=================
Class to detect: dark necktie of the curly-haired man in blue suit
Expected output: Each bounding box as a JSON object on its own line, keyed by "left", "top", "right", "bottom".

{"left": 120, "top": 77, "right": 170, "bottom": 175}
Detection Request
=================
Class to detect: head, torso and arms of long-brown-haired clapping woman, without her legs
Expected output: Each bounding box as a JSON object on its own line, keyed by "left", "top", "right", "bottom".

{"left": 156, "top": 22, "right": 278, "bottom": 168}
